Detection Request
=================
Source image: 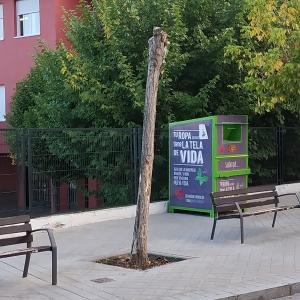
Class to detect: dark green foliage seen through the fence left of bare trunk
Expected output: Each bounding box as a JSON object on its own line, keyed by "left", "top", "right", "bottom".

{"left": 23, "top": 129, "right": 134, "bottom": 207}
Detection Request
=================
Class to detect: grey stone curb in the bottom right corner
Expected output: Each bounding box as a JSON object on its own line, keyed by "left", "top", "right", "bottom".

{"left": 216, "top": 282, "right": 300, "bottom": 300}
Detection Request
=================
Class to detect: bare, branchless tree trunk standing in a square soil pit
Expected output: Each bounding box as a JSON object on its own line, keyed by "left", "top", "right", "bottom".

{"left": 131, "top": 27, "right": 168, "bottom": 268}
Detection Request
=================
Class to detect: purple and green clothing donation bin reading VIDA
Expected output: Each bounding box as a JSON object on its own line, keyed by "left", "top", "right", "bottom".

{"left": 169, "top": 115, "right": 250, "bottom": 217}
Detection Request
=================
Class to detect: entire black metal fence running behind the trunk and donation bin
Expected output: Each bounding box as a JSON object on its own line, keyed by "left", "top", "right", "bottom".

{"left": 0, "top": 127, "right": 300, "bottom": 215}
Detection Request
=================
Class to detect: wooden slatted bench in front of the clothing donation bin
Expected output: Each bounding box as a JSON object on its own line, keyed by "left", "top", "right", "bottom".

{"left": 211, "top": 185, "right": 300, "bottom": 244}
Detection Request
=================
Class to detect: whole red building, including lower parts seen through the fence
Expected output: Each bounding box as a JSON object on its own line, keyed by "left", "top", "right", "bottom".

{"left": 0, "top": 0, "right": 104, "bottom": 215}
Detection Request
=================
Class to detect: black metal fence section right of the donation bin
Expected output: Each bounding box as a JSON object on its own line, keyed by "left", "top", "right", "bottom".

{"left": 249, "top": 127, "right": 300, "bottom": 185}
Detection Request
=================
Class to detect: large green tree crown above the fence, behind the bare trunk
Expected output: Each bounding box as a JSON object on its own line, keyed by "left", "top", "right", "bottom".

{"left": 9, "top": 0, "right": 251, "bottom": 128}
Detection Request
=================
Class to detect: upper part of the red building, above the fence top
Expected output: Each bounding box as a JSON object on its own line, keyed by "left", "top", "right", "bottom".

{"left": 0, "top": 0, "right": 79, "bottom": 128}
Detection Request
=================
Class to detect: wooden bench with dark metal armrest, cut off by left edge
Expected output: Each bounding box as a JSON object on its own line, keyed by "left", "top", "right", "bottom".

{"left": 0, "top": 215, "right": 57, "bottom": 285}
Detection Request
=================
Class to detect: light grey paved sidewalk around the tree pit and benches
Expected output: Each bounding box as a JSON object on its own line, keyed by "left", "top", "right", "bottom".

{"left": 0, "top": 210, "right": 300, "bottom": 300}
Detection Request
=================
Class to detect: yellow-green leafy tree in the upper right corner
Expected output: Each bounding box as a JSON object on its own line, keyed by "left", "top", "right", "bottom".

{"left": 226, "top": 0, "right": 300, "bottom": 112}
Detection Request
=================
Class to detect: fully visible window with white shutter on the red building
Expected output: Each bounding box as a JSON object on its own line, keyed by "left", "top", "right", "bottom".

{"left": 16, "top": 0, "right": 40, "bottom": 36}
